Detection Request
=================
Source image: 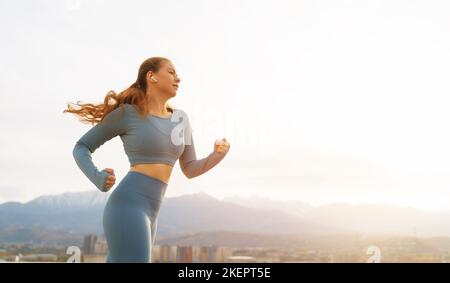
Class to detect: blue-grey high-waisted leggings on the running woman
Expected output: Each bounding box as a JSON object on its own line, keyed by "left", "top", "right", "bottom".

{"left": 103, "top": 171, "right": 167, "bottom": 263}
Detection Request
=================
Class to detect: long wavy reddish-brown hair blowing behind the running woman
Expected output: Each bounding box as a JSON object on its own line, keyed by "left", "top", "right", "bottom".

{"left": 63, "top": 57, "right": 174, "bottom": 124}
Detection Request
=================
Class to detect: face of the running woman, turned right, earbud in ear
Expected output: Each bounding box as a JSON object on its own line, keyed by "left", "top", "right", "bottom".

{"left": 147, "top": 61, "right": 181, "bottom": 97}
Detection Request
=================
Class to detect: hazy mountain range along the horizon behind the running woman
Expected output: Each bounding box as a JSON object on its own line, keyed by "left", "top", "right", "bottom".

{"left": 0, "top": 191, "right": 450, "bottom": 247}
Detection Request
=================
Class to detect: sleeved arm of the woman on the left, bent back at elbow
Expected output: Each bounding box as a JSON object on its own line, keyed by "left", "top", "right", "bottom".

{"left": 72, "top": 104, "right": 129, "bottom": 192}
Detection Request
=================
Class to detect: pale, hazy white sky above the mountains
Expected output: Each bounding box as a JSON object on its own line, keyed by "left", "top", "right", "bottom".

{"left": 0, "top": 0, "right": 450, "bottom": 210}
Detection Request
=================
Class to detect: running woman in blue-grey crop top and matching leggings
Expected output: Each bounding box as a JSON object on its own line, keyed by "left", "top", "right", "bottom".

{"left": 64, "top": 57, "right": 230, "bottom": 262}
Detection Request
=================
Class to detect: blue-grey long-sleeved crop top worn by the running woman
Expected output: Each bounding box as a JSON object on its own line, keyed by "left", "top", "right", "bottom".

{"left": 72, "top": 104, "right": 226, "bottom": 192}
